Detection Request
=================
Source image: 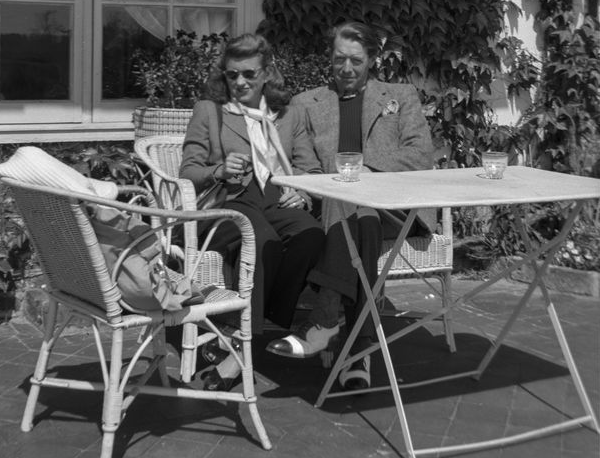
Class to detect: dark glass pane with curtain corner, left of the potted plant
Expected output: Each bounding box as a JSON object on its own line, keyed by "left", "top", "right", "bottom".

{"left": 102, "top": 6, "right": 168, "bottom": 99}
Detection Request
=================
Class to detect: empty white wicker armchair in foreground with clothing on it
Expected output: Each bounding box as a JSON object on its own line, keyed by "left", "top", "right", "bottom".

{"left": 1, "top": 178, "right": 271, "bottom": 458}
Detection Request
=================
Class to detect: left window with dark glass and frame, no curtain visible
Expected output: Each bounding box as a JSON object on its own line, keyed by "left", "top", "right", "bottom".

{"left": 0, "top": 0, "right": 82, "bottom": 124}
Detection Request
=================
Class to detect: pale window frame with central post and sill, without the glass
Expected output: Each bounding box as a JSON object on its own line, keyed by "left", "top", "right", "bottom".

{"left": 0, "top": 0, "right": 264, "bottom": 143}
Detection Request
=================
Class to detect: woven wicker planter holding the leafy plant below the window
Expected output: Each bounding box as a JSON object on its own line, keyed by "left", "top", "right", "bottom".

{"left": 133, "top": 107, "right": 193, "bottom": 140}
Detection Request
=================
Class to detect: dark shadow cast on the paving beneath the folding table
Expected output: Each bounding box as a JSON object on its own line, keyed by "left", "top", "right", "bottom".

{"left": 253, "top": 319, "right": 568, "bottom": 413}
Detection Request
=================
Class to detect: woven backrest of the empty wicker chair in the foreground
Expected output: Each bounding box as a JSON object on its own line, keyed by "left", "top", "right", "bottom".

{"left": 1, "top": 178, "right": 121, "bottom": 322}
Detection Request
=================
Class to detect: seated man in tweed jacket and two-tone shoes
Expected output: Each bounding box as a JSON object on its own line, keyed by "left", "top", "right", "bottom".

{"left": 267, "top": 22, "right": 435, "bottom": 389}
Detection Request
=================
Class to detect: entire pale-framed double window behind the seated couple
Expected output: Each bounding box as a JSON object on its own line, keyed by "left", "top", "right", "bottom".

{"left": 0, "top": 0, "right": 262, "bottom": 142}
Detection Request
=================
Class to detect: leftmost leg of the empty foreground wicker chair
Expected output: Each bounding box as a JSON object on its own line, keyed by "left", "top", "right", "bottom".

{"left": 21, "top": 297, "right": 58, "bottom": 432}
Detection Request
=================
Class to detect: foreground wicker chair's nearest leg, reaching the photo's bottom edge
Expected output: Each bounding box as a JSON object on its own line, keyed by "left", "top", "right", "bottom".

{"left": 101, "top": 329, "right": 123, "bottom": 458}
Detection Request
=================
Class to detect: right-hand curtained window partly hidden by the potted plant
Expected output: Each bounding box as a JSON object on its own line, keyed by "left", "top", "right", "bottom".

{"left": 93, "top": 0, "right": 239, "bottom": 122}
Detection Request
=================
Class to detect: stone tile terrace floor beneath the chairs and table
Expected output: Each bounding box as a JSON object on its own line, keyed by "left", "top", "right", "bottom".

{"left": 0, "top": 280, "right": 600, "bottom": 458}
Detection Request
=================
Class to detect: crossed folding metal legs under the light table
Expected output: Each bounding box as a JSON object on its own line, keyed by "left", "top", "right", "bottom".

{"left": 315, "top": 202, "right": 600, "bottom": 458}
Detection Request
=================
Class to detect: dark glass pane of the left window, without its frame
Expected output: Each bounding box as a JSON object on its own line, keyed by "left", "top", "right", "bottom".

{"left": 0, "top": 3, "right": 73, "bottom": 100}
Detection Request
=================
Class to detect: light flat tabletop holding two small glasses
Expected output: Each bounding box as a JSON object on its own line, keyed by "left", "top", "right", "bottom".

{"left": 272, "top": 166, "right": 600, "bottom": 210}
